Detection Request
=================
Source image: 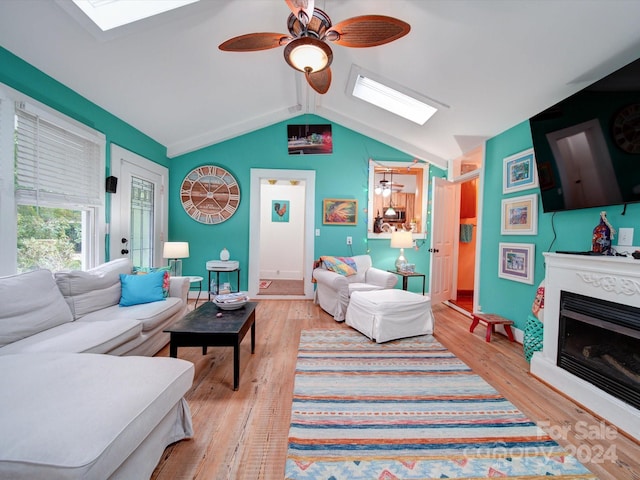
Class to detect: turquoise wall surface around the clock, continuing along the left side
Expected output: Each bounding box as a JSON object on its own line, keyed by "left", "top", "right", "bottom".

{"left": 0, "top": 47, "right": 444, "bottom": 291}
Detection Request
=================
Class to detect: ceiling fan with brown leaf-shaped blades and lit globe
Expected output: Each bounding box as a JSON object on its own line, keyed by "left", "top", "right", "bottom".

{"left": 218, "top": 0, "right": 411, "bottom": 94}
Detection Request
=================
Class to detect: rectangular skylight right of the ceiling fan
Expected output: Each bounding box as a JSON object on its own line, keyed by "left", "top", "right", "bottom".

{"left": 348, "top": 65, "right": 448, "bottom": 125}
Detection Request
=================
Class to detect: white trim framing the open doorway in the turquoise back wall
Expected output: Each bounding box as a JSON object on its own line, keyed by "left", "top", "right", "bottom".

{"left": 247, "top": 168, "right": 316, "bottom": 299}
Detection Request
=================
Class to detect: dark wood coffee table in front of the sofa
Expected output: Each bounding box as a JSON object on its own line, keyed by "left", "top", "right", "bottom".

{"left": 164, "top": 302, "right": 258, "bottom": 390}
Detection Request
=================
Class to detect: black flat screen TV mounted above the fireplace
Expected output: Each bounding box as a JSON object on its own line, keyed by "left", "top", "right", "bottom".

{"left": 529, "top": 59, "right": 640, "bottom": 212}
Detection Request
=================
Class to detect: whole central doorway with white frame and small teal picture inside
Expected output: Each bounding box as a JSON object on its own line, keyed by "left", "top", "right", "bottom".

{"left": 248, "top": 169, "right": 315, "bottom": 299}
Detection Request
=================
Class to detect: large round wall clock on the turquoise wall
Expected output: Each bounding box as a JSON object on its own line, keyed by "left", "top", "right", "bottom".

{"left": 180, "top": 165, "right": 240, "bottom": 225}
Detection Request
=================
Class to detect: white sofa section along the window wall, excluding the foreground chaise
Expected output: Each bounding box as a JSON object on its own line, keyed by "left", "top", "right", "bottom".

{"left": 0, "top": 258, "right": 189, "bottom": 356}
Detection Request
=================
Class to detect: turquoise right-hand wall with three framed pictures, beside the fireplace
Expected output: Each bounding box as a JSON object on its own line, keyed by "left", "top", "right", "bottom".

{"left": 479, "top": 120, "right": 640, "bottom": 330}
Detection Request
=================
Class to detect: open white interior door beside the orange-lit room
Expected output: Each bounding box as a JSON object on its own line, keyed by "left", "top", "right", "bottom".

{"left": 429, "top": 178, "right": 460, "bottom": 303}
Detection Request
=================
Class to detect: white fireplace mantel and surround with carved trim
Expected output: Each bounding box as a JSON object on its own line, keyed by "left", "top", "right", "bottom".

{"left": 531, "top": 253, "right": 640, "bottom": 440}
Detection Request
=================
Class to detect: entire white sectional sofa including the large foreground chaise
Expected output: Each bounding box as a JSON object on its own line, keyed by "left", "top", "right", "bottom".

{"left": 0, "top": 259, "right": 194, "bottom": 479}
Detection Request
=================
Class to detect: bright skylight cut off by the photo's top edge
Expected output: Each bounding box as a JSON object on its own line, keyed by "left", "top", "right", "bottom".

{"left": 73, "top": 0, "right": 198, "bottom": 32}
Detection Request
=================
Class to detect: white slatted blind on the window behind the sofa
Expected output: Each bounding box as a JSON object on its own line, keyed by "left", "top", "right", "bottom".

{"left": 16, "top": 104, "right": 104, "bottom": 206}
